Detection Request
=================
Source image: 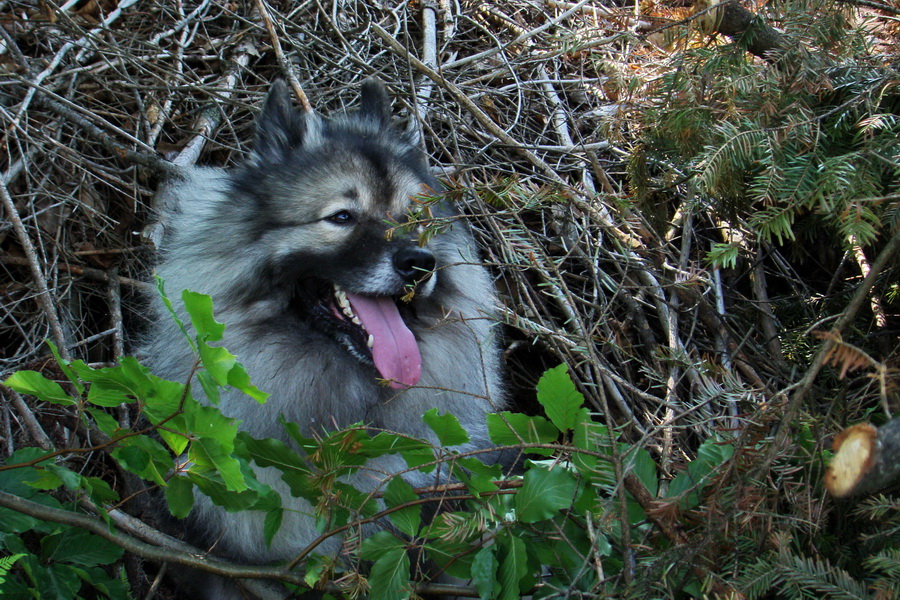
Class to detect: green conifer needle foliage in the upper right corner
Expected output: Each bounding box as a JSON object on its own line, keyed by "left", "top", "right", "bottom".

{"left": 631, "top": 2, "right": 900, "bottom": 266}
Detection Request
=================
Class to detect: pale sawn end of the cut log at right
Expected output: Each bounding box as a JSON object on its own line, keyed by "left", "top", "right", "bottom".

{"left": 825, "top": 423, "right": 878, "bottom": 498}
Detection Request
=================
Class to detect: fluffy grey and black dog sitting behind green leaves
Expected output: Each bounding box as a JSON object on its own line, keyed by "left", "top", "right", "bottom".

{"left": 143, "top": 80, "right": 504, "bottom": 599}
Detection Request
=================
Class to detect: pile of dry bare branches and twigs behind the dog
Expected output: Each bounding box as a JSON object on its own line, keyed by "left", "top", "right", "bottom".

{"left": 0, "top": 0, "right": 892, "bottom": 596}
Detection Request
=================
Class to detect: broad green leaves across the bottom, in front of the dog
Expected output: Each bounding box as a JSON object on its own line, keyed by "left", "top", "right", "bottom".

{"left": 8, "top": 292, "right": 864, "bottom": 599}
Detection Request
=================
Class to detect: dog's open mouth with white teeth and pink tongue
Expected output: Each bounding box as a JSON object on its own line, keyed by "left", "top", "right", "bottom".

{"left": 320, "top": 285, "right": 422, "bottom": 389}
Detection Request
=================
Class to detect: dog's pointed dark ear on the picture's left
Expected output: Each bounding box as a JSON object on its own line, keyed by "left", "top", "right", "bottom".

{"left": 253, "top": 79, "right": 318, "bottom": 162}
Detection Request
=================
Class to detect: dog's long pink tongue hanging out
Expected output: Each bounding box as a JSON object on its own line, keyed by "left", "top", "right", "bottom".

{"left": 347, "top": 292, "right": 422, "bottom": 389}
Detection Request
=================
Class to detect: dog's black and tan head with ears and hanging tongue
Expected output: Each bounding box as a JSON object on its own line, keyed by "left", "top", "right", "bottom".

{"left": 234, "top": 80, "right": 460, "bottom": 388}
